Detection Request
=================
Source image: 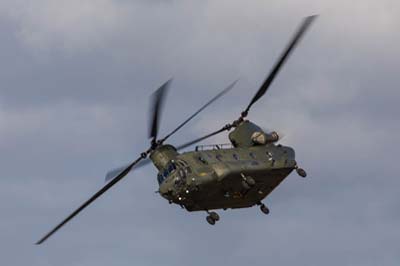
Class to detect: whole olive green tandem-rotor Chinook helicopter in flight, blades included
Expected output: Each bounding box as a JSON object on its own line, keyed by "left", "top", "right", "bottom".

{"left": 36, "top": 16, "right": 316, "bottom": 244}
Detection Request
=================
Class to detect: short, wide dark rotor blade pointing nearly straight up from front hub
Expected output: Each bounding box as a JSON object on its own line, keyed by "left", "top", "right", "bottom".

{"left": 149, "top": 79, "right": 172, "bottom": 141}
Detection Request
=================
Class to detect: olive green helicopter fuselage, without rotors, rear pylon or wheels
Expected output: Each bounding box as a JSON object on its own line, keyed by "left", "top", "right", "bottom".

{"left": 155, "top": 144, "right": 296, "bottom": 211}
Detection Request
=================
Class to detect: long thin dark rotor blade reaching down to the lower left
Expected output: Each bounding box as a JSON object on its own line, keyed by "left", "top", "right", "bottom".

{"left": 36, "top": 157, "right": 142, "bottom": 245}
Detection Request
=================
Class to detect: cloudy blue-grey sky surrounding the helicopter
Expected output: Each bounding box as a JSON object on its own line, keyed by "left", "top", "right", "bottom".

{"left": 0, "top": 0, "right": 400, "bottom": 266}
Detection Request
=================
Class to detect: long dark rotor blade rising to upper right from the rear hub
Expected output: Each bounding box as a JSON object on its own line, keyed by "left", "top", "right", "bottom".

{"left": 244, "top": 15, "right": 317, "bottom": 115}
